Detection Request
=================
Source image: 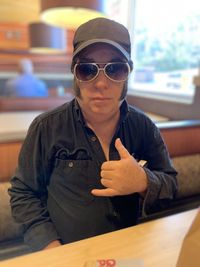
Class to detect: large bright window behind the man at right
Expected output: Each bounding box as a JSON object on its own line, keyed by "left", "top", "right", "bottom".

{"left": 105, "top": 0, "right": 200, "bottom": 103}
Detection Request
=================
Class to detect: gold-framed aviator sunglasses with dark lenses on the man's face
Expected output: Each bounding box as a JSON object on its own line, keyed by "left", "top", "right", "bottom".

{"left": 74, "top": 62, "right": 130, "bottom": 82}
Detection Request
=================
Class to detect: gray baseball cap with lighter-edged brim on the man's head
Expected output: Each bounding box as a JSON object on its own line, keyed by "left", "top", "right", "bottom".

{"left": 72, "top": 18, "right": 133, "bottom": 68}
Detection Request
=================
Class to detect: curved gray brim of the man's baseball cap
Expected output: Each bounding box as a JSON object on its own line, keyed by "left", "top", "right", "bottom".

{"left": 73, "top": 39, "right": 130, "bottom": 61}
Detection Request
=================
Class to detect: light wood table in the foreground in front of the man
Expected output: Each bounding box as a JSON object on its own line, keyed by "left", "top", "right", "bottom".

{"left": 0, "top": 210, "right": 197, "bottom": 267}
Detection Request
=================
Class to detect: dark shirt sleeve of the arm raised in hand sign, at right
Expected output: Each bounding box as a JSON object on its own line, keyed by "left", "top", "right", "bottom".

{"left": 142, "top": 120, "right": 177, "bottom": 216}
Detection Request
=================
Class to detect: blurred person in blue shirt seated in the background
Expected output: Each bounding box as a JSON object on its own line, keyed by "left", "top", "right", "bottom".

{"left": 3, "top": 58, "right": 48, "bottom": 97}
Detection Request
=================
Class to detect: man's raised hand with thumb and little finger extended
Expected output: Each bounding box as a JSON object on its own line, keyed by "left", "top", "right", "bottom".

{"left": 91, "top": 138, "right": 147, "bottom": 197}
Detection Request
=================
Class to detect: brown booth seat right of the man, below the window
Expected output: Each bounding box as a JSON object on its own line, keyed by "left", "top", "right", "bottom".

{"left": 140, "top": 120, "right": 200, "bottom": 222}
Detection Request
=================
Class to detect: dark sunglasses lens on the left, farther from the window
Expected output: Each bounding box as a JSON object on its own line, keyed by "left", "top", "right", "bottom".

{"left": 75, "top": 63, "right": 98, "bottom": 81}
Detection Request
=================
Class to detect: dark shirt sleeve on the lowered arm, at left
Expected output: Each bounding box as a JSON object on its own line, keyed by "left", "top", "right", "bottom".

{"left": 9, "top": 119, "right": 60, "bottom": 251}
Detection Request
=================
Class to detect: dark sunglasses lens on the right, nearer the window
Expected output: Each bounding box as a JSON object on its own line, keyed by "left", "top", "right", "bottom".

{"left": 105, "top": 62, "right": 129, "bottom": 81}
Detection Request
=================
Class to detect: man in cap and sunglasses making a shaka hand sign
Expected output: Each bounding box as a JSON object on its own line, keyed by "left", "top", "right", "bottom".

{"left": 10, "top": 18, "right": 176, "bottom": 250}
